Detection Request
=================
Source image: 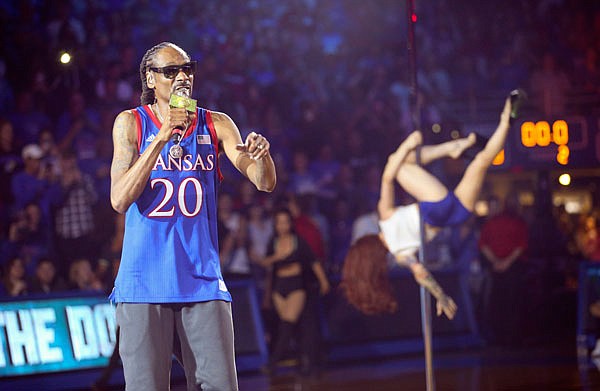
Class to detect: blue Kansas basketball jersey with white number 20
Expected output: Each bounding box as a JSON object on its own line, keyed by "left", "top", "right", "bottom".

{"left": 110, "top": 106, "right": 231, "bottom": 303}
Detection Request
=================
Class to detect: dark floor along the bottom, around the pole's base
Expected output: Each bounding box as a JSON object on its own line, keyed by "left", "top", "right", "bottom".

{"left": 172, "top": 343, "right": 600, "bottom": 391}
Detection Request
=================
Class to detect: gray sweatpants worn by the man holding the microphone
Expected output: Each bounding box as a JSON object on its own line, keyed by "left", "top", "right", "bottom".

{"left": 116, "top": 300, "right": 238, "bottom": 391}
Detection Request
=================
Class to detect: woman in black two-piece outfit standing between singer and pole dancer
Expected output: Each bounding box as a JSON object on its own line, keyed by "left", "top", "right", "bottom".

{"left": 262, "top": 209, "right": 330, "bottom": 371}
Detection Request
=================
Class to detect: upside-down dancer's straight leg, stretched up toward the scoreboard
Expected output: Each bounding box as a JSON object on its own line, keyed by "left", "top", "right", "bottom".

{"left": 454, "top": 98, "right": 511, "bottom": 211}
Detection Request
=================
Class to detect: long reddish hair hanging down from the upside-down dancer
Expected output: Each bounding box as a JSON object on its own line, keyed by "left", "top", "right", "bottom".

{"left": 340, "top": 235, "right": 398, "bottom": 315}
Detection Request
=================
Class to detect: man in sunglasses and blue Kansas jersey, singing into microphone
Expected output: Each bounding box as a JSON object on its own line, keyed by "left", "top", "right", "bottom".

{"left": 111, "top": 42, "right": 276, "bottom": 391}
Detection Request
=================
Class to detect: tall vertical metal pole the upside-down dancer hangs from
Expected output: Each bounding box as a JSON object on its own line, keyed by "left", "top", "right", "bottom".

{"left": 406, "top": 0, "right": 435, "bottom": 391}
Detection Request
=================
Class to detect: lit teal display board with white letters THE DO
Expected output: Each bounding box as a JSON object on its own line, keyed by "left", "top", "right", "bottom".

{"left": 0, "top": 296, "right": 116, "bottom": 377}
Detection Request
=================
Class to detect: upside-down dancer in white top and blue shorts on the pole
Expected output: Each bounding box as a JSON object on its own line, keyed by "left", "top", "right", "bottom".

{"left": 341, "top": 97, "right": 512, "bottom": 385}
